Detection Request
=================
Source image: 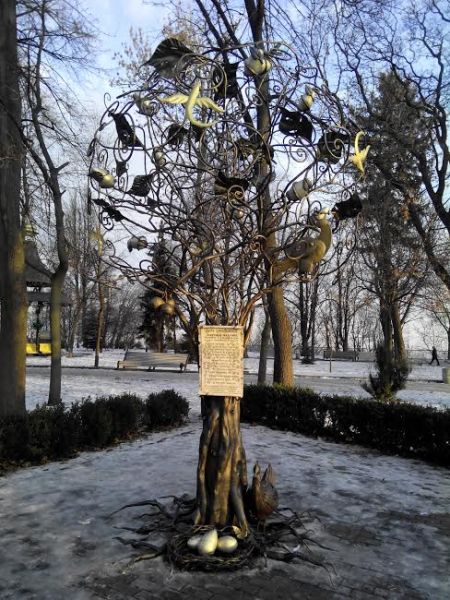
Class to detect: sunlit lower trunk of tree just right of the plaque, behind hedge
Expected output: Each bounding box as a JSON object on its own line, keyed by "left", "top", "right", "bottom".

{"left": 269, "top": 285, "right": 294, "bottom": 385}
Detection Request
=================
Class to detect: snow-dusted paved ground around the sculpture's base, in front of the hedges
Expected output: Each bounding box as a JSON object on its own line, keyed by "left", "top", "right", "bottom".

{"left": 0, "top": 422, "right": 450, "bottom": 600}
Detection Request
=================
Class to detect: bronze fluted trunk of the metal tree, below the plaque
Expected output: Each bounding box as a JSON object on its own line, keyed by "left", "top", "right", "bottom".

{"left": 195, "top": 396, "right": 249, "bottom": 534}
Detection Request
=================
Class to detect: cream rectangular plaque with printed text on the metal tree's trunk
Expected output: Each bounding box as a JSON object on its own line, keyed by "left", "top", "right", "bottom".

{"left": 199, "top": 325, "right": 244, "bottom": 398}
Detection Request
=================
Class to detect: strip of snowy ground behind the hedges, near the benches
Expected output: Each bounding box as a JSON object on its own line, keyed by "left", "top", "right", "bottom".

{"left": 27, "top": 350, "right": 450, "bottom": 412}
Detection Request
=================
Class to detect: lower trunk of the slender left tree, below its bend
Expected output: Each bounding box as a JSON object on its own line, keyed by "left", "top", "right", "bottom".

{"left": 48, "top": 265, "right": 67, "bottom": 406}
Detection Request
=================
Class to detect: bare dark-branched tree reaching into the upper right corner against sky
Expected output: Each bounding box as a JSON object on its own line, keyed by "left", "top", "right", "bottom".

{"left": 315, "top": 0, "right": 450, "bottom": 289}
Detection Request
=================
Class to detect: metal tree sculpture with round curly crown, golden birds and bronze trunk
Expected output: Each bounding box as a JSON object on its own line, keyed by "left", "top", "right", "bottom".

{"left": 89, "top": 38, "right": 368, "bottom": 568}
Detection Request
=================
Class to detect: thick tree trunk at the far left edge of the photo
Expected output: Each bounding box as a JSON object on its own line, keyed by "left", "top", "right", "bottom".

{"left": 0, "top": 0, "right": 27, "bottom": 416}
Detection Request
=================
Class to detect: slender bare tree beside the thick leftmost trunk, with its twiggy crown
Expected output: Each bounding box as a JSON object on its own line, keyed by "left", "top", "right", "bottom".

{"left": 18, "top": 0, "right": 93, "bottom": 404}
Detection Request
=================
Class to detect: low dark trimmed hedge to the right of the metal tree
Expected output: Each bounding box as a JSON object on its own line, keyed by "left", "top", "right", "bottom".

{"left": 241, "top": 385, "right": 450, "bottom": 466}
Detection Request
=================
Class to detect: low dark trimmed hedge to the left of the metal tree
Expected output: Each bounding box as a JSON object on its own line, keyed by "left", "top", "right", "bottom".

{"left": 0, "top": 390, "right": 189, "bottom": 472}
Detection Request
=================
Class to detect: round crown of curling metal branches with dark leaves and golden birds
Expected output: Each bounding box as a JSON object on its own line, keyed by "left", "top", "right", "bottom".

{"left": 89, "top": 38, "right": 365, "bottom": 310}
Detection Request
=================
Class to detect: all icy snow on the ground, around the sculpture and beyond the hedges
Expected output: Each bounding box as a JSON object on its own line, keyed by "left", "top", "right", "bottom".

{"left": 0, "top": 353, "right": 450, "bottom": 600}
